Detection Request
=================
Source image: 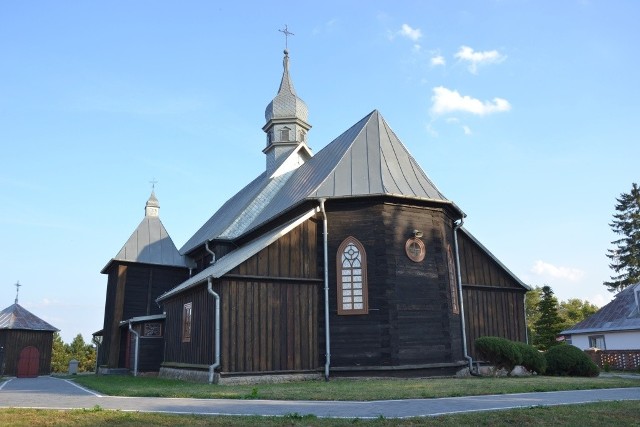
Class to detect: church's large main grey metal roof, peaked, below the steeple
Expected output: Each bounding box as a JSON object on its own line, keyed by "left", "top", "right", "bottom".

{"left": 180, "top": 110, "right": 464, "bottom": 254}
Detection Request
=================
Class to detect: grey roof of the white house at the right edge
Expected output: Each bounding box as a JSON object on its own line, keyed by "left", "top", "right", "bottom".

{"left": 560, "top": 284, "right": 640, "bottom": 335}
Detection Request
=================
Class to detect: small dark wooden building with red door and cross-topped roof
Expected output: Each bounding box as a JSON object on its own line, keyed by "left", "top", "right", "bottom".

{"left": 0, "top": 283, "right": 58, "bottom": 378}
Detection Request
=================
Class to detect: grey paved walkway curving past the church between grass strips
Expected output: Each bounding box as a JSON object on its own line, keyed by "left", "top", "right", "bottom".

{"left": 0, "top": 377, "right": 640, "bottom": 418}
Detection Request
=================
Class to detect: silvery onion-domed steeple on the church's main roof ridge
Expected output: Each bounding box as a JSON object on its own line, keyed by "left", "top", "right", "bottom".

{"left": 262, "top": 49, "right": 311, "bottom": 173}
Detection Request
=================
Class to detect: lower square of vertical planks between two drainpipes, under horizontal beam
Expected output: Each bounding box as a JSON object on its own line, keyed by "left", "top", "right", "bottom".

{"left": 221, "top": 280, "right": 319, "bottom": 372}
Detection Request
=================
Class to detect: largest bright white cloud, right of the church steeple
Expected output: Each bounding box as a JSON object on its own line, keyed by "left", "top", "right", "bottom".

{"left": 431, "top": 86, "right": 511, "bottom": 116}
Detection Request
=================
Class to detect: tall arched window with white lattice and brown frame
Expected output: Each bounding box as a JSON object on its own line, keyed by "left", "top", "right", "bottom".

{"left": 336, "top": 237, "right": 369, "bottom": 314}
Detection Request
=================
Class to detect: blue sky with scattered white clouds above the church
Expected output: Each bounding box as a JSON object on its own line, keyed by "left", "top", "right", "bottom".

{"left": 0, "top": 0, "right": 640, "bottom": 341}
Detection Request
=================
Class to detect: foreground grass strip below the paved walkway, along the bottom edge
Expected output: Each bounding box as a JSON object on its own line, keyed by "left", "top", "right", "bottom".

{"left": 0, "top": 402, "right": 640, "bottom": 427}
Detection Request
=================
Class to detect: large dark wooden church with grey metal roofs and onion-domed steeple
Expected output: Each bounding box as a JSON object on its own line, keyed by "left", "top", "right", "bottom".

{"left": 95, "top": 50, "right": 528, "bottom": 382}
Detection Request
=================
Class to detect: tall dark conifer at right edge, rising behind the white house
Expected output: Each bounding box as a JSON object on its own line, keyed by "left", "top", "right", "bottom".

{"left": 604, "top": 183, "right": 640, "bottom": 292}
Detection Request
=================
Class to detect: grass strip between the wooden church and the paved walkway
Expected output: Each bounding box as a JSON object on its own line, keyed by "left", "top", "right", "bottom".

{"left": 73, "top": 375, "right": 640, "bottom": 406}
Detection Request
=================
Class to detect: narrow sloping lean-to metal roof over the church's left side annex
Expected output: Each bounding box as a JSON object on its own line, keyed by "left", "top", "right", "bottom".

{"left": 156, "top": 209, "right": 316, "bottom": 302}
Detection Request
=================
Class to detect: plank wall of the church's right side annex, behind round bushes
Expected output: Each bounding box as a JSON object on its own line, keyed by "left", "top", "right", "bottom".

{"left": 458, "top": 233, "right": 526, "bottom": 358}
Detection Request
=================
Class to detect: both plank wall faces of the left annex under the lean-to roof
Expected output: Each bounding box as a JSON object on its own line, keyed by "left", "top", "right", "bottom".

{"left": 165, "top": 219, "right": 322, "bottom": 373}
